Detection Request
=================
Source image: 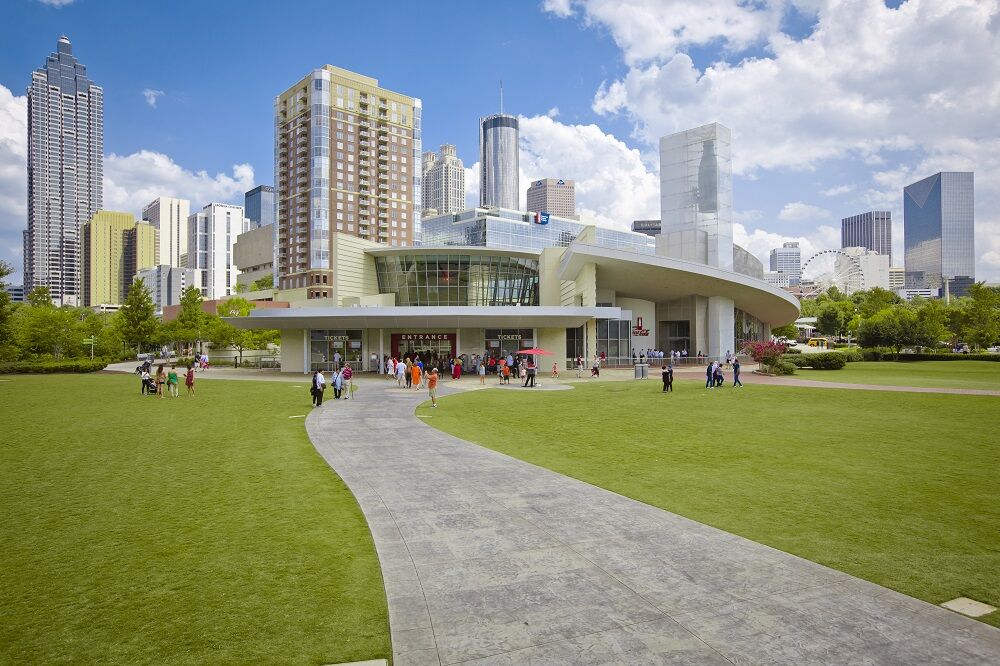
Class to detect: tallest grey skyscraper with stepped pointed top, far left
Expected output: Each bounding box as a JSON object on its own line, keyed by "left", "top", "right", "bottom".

{"left": 24, "top": 35, "right": 104, "bottom": 305}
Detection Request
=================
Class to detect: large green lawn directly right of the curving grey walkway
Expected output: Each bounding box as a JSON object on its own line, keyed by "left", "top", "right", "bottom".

{"left": 417, "top": 376, "right": 1000, "bottom": 626}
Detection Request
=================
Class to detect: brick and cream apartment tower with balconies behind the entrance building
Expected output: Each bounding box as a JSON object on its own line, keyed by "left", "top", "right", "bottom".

{"left": 274, "top": 65, "right": 421, "bottom": 298}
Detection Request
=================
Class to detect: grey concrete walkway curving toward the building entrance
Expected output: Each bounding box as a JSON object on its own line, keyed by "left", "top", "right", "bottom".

{"left": 306, "top": 385, "right": 1000, "bottom": 666}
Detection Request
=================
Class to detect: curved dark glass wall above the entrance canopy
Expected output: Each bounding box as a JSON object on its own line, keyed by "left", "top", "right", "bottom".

{"left": 375, "top": 255, "right": 538, "bottom": 306}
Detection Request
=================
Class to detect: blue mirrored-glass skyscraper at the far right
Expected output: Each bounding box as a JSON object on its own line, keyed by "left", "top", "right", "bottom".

{"left": 903, "top": 171, "right": 976, "bottom": 296}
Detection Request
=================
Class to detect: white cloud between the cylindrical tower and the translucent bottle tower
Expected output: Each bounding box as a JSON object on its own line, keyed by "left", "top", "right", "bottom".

{"left": 516, "top": 116, "right": 660, "bottom": 229}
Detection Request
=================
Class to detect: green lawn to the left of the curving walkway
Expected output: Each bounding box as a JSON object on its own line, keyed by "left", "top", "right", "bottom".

{"left": 0, "top": 375, "right": 390, "bottom": 664}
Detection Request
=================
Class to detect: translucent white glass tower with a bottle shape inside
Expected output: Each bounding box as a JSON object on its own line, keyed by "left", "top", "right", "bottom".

{"left": 660, "top": 123, "right": 733, "bottom": 270}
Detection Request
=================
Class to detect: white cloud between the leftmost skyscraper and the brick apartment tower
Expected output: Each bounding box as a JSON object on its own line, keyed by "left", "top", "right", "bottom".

{"left": 104, "top": 150, "right": 256, "bottom": 213}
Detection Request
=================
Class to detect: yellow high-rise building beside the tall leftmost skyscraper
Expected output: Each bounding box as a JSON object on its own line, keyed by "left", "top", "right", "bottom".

{"left": 82, "top": 210, "right": 157, "bottom": 307}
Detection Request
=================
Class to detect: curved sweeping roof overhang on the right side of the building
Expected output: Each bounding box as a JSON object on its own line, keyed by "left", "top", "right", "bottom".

{"left": 559, "top": 243, "right": 800, "bottom": 326}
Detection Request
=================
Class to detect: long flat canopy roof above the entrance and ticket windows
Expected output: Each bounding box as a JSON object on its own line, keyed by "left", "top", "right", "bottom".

{"left": 224, "top": 305, "right": 621, "bottom": 330}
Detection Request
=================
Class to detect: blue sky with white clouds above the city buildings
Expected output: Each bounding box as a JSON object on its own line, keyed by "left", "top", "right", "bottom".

{"left": 0, "top": 0, "right": 1000, "bottom": 280}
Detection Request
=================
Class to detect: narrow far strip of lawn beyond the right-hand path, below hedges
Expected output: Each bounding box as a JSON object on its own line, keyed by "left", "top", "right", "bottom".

{"left": 795, "top": 361, "right": 1000, "bottom": 391}
